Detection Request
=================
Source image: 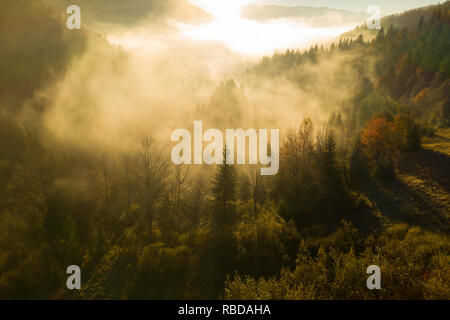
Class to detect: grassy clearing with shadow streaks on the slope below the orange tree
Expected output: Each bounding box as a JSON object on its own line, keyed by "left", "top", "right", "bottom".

{"left": 363, "top": 128, "right": 450, "bottom": 232}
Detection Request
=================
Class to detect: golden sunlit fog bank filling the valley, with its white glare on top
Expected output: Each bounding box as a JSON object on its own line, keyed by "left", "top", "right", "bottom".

{"left": 29, "top": 1, "right": 370, "bottom": 155}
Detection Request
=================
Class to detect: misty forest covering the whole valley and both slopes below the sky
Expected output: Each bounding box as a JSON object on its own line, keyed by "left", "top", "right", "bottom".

{"left": 0, "top": 0, "right": 450, "bottom": 300}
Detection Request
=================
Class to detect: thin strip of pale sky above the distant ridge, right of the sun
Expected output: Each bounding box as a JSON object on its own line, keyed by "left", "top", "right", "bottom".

{"left": 250, "top": 0, "right": 445, "bottom": 14}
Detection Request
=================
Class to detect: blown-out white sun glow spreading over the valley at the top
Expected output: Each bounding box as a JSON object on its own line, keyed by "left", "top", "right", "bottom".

{"left": 174, "top": 0, "right": 355, "bottom": 55}
